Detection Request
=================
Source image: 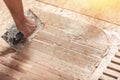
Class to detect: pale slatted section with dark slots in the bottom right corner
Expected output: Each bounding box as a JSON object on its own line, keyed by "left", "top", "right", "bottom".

{"left": 99, "top": 46, "right": 120, "bottom": 80}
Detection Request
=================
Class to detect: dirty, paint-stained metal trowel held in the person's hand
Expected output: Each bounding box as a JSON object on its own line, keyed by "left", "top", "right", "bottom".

{"left": 2, "top": 10, "right": 42, "bottom": 51}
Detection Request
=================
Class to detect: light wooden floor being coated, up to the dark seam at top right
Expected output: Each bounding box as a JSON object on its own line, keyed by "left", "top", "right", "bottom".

{"left": 0, "top": 0, "right": 120, "bottom": 80}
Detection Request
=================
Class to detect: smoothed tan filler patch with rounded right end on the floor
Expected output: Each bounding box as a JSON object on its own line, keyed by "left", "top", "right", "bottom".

{"left": 30, "top": 1, "right": 109, "bottom": 79}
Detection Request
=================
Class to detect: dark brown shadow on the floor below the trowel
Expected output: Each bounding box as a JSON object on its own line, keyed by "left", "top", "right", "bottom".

{"left": 0, "top": 46, "right": 29, "bottom": 80}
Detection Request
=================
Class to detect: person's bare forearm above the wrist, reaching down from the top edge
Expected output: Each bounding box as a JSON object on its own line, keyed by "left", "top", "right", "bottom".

{"left": 4, "top": 0, "right": 25, "bottom": 24}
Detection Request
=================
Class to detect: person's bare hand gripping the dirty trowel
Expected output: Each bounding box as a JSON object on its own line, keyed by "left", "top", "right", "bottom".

{"left": 17, "top": 17, "right": 36, "bottom": 38}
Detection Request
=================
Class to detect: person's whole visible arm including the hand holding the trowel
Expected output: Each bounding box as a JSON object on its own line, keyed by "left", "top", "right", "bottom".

{"left": 4, "top": 0, "right": 36, "bottom": 38}
